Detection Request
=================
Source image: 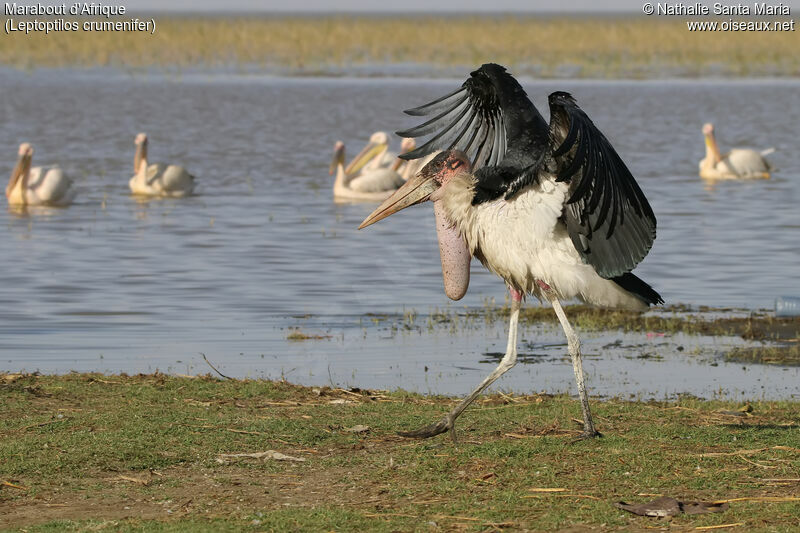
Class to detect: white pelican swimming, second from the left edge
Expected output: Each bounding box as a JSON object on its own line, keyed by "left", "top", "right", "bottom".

{"left": 128, "top": 133, "right": 194, "bottom": 197}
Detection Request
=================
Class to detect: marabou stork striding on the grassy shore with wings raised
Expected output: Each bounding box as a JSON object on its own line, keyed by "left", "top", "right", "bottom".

{"left": 359, "top": 64, "right": 663, "bottom": 438}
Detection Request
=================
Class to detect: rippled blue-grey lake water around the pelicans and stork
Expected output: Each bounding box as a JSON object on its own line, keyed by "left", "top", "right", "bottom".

{"left": 0, "top": 70, "right": 800, "bottom": 397}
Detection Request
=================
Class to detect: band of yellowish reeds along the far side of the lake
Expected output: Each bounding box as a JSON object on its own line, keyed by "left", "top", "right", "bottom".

{"left": 0, "top": 16, "right": 800, "bottom": 78}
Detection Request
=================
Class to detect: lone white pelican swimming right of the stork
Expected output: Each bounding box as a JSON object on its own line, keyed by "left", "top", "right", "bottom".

{"left": 699, "top": 123, "right": 775, "bottom": 180}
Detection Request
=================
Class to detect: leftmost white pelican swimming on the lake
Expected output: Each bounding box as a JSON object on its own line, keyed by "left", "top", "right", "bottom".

{"left": 6, "top": 143, "right": 75, "bottom": 207}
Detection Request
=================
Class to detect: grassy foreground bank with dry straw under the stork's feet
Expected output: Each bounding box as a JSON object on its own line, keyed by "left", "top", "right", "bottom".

{"left": 0, "top": 374, "right": 800, "bottom": 532}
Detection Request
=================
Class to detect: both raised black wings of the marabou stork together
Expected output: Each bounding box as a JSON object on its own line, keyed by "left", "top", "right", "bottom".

{"left": 397, "top": 63, "right": 656, "bottom": 279}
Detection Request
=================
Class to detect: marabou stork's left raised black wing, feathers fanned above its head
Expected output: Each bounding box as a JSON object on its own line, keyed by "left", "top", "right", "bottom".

{"left": 397, "top": 63, "right": 548, "bottom": 187}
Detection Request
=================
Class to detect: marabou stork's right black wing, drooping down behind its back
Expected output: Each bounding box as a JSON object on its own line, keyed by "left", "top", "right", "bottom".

{"left": 550, "top": 92, "right": 656, "bottom": 279}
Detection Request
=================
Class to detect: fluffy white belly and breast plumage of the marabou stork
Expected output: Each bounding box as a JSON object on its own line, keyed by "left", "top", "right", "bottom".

{"left": 442, "top": 176, "right": 647, "bottom": 309}
